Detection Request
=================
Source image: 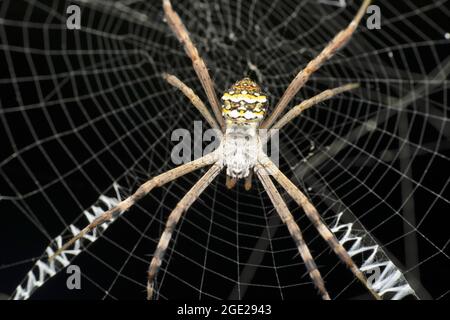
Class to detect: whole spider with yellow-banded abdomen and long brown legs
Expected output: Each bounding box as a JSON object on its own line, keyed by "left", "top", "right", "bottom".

{"left": 50, "top": 0, "right": 381, "bottom": 300}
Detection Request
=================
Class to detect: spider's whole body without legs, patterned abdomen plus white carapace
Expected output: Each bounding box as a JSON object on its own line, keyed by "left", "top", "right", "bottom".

{"left": 222, "top": 78, "right": 267, "bottom": 179}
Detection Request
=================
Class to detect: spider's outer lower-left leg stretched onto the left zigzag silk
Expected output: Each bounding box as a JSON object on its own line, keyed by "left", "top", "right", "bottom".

{"left": 49, "top": 152, "right": 217, "bottom": 261}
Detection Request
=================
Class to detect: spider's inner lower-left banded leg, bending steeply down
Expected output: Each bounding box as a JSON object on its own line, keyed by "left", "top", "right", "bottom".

{"left": 147, "top": 164, "right": 222, "bottom": 300}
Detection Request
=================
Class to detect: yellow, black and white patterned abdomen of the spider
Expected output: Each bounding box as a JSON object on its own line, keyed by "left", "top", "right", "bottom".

{"left": 222, "top": 78, "right": 267, "bottom": 123}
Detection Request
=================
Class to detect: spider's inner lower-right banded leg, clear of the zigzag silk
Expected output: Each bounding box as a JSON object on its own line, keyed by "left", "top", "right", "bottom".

{"left": 256, "top": 167, "right": 330, "bottom": 300}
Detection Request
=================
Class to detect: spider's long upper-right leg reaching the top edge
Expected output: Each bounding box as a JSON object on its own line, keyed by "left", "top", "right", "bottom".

{"left": 261, "top": 0, "right": 371, "bottom": 129}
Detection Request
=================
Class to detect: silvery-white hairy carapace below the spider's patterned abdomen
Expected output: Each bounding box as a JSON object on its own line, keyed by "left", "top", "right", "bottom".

{"left": 222, "top": 124, "right": 260, "bottom": 179}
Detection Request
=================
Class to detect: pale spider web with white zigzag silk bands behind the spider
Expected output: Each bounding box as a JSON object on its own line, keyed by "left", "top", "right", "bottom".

{"left": 0, "top": 0, "right": 450, "bottom": 299}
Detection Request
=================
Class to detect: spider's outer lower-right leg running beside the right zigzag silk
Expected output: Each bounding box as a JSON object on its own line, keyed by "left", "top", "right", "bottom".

{"left": 260, "top": 155, "right": 381, "bottom": 300}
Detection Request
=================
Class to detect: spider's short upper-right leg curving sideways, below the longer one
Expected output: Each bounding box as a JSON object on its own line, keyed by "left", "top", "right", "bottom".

{"left": 271, "top": 83, "right": 359, "bottom": 130}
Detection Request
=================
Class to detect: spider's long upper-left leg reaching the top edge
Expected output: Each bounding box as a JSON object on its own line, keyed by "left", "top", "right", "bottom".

{"left": 163, "top": 0, "right": 224, "bottom": 128}
